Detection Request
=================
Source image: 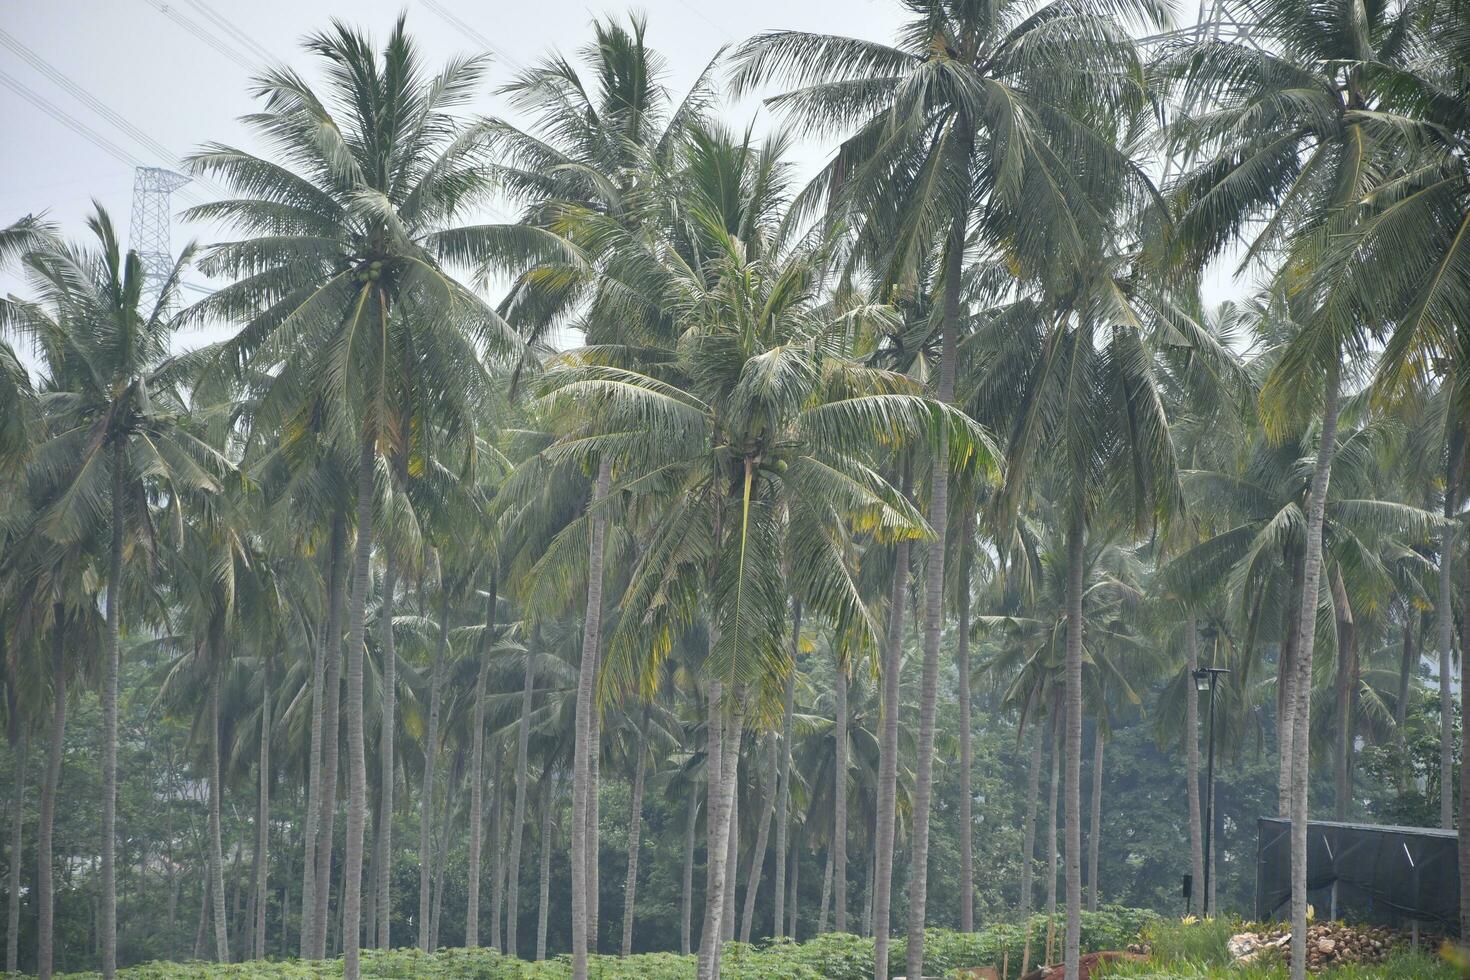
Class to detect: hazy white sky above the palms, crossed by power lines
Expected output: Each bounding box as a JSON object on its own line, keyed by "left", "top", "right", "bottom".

{"left": 0, "top": 0, "right": 1230, "bottom": 348}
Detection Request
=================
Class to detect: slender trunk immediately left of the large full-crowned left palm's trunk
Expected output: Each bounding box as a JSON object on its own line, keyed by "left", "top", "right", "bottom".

{"left": 310, "top": 513, "right": 348, "bottom": 959}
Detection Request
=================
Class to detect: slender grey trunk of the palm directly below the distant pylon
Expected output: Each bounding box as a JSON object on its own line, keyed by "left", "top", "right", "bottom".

{"left": 98, "top": 442, "right": 123, "bottom": 980}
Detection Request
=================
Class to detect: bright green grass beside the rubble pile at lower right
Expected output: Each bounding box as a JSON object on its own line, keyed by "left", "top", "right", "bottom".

{"left": 1098, "top": 918, "right": 1463, "bottom": 980}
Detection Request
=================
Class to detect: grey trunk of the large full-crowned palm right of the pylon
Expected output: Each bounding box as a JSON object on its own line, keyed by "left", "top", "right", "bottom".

{"left": 343, "top": 438, "right": 378, "bottom": 980}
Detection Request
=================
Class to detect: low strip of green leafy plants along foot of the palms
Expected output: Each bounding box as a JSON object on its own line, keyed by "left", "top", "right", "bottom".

{"left": 40, "top": 908, "right": 1157, "bottom": 980}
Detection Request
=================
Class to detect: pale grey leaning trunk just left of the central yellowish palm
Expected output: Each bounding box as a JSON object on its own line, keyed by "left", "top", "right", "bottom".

{"left": 572, "top": 457, "right": 613, "bottom": 980}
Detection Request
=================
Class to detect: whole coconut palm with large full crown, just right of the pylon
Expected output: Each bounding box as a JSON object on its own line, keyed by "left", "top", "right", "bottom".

{"left": 190, "top": 18, "right": 513, "bottom": 977}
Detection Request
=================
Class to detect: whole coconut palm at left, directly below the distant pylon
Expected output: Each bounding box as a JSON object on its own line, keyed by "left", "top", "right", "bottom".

{"left": 7, "top": 206, "right": 229, "bottom": 977}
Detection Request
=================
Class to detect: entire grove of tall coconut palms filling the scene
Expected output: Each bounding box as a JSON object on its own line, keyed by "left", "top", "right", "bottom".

{"left": 0, "top": 0, "right": 1470, "bottom": 980}
